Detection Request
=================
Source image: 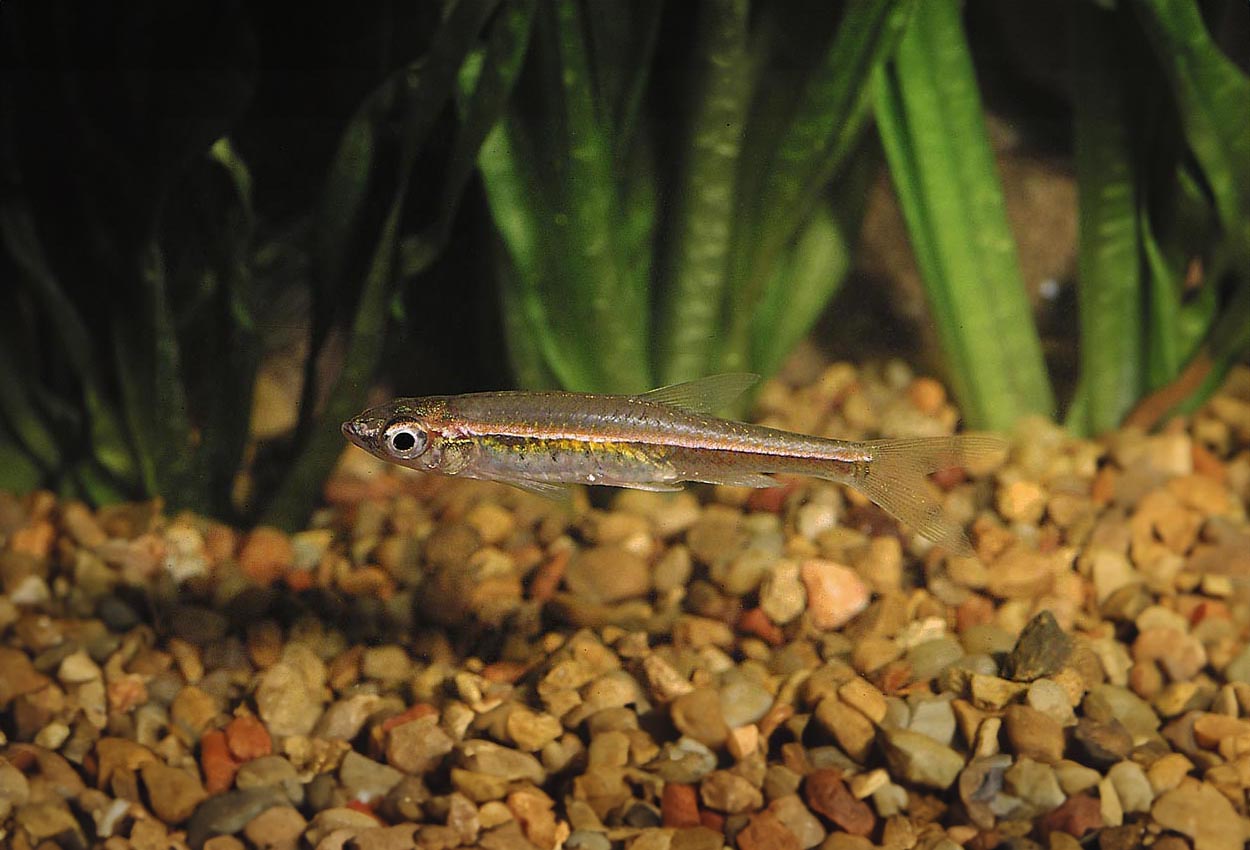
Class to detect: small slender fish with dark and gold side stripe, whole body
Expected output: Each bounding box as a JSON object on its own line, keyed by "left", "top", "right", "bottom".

{"left": 343, "top": 374, "right": 1003, "bottom": 554}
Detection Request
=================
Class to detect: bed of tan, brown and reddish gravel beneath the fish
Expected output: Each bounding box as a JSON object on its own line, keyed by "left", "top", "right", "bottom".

{"left": 0, "top": 364, "right": 1250, "bottom": 850}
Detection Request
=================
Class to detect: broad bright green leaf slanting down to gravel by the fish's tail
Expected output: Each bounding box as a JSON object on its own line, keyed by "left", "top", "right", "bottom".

{"left": 876, "top": 0, "right": 1054, "bottom": 429}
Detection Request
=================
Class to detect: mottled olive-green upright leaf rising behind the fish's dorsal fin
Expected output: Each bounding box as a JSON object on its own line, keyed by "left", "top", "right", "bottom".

{"left": 655, "top": 0, "right": 750, "bottom": 384}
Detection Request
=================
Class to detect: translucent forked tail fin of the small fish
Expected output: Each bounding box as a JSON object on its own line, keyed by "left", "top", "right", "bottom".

{"left": 815, "top": 435, "right": 1006, "bottom": 555}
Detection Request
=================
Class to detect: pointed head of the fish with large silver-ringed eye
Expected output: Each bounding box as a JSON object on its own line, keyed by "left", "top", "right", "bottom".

{"left": 343, "top": 398, "right": 445, "bottom": 470}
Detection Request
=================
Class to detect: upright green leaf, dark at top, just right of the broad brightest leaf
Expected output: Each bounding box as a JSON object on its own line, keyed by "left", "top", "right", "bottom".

{"left": 1068, "top": 4, "right": 1145, "bottom": 434}
